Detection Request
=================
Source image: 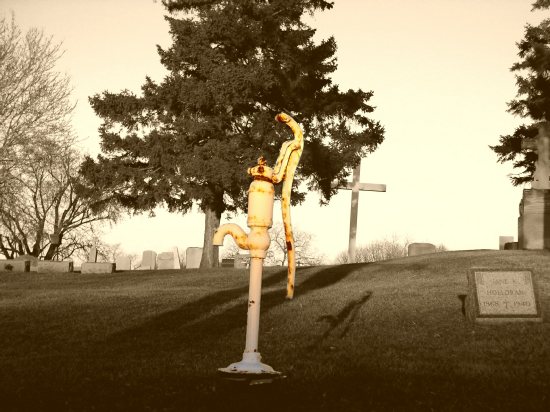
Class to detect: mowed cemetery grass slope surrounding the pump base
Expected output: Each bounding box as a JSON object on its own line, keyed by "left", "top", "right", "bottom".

{"left": 0, "top": 251, "right": 550, "bottom": 411}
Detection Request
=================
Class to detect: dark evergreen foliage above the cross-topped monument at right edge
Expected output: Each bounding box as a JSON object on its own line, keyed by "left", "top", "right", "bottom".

{"left": 490, "top": 0, "right": 550, "bottom": 186}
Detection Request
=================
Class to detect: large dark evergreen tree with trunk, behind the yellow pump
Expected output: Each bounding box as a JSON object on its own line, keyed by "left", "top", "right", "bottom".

{"left": 82, "top": 0, "right": 384, "bottom": 266}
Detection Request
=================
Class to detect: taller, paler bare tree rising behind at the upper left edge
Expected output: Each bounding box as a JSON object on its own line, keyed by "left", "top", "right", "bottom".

{"left": 0, "top": 14, "right": 74, "bottom": 187}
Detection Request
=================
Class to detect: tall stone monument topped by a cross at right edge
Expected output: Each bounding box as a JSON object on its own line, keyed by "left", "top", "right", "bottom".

{"left": 518, "top": 122, "right": 550, "bottom": 249}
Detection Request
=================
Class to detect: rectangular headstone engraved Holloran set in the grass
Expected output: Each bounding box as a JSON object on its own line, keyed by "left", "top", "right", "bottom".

{"left": 466, "top": 268, "right": 542, "bottom": 323}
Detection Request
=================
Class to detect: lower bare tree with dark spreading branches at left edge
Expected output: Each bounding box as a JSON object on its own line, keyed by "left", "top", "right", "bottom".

{"left": 0, "top": 140, "right": 119, "bottom": 260}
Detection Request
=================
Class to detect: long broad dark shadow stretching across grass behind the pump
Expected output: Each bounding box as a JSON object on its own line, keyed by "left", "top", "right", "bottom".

{"left": 101, "top": 264, "right": 370, "bottom": 356}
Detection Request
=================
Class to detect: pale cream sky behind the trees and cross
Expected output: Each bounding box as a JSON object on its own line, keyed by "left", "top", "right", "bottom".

{"left": 0, "top": 0, "right": 548, "bottom": 262}
